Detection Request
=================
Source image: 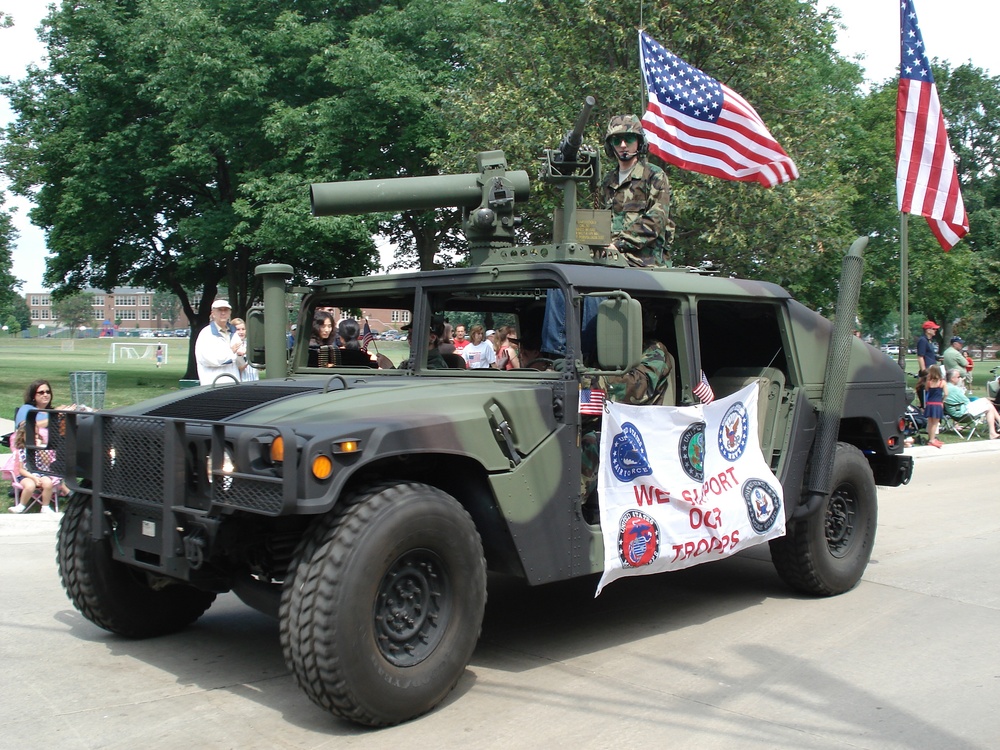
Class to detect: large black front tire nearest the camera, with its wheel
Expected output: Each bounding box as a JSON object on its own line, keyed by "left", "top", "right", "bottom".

{"left": 280, "top": 483, "right": 486, "bottom": 726}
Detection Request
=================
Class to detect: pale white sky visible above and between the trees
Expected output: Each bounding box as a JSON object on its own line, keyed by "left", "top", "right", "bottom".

{"left": 0, "top": 0, "right": 1000, "bottom": 293}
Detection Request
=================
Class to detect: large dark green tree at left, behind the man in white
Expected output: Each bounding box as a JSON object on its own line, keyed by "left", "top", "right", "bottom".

{"left": 3, "top": 0, "right": 375, "bottom": 370}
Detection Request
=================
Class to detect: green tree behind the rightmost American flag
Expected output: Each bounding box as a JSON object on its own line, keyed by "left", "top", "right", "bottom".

{"left": 839, "top": 64, "right": 1000, "bottom": 341}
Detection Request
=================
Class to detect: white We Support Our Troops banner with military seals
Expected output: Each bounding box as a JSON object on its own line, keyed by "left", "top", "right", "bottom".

{"left": 595, "top": 383, "right": 785, "bottom": 596}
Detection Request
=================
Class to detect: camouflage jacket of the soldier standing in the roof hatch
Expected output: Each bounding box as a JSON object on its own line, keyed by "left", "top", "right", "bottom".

{"left": 599, "top": 161, "right": 674, "bottom": 266}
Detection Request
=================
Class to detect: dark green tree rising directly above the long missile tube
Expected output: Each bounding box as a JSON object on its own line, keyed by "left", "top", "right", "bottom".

{"left": 268, "top": 0, "right": 488, "bottom": 270}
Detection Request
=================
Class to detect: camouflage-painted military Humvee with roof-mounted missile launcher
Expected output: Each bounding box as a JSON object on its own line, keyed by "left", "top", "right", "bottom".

{"left": 35, "top": 101, "right": 911, "bottom": 726}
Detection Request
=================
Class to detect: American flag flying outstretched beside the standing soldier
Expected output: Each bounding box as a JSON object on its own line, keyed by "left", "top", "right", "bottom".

{"left": 639, "top": 31, "right": 799, "bottom": 187}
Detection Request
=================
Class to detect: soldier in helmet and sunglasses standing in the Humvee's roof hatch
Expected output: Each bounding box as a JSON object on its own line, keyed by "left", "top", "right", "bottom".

{"left": 598, "top": 115, "right": 674, "bottom": 267}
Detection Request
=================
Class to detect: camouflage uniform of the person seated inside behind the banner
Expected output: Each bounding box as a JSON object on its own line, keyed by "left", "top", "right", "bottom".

{"left": 580, "top": 341, "right": 670, "bottom": 498}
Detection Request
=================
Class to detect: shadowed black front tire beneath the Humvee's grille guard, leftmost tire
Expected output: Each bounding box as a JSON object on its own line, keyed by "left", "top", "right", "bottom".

{"left": 56, "top": 495, "right": 215, "bottom": 638}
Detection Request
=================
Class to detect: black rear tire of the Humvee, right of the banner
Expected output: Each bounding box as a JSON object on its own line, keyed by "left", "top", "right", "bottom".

{"left": 770, "top": 443, "right": 878, "bottom": 596}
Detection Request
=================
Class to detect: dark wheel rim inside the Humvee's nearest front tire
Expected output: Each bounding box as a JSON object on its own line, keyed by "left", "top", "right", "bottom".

{"left": 375, "top": 549, "right": 451, "bottom": 667}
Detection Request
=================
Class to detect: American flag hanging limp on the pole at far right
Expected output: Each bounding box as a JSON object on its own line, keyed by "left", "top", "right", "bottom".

{"left": 896, "top": 0, "right": 969, "bottom": 250}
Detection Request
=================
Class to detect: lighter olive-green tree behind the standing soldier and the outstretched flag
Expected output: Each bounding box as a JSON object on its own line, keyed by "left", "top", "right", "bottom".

{"left": 439, "top": 0, "right": 861, "bottom": 310}
